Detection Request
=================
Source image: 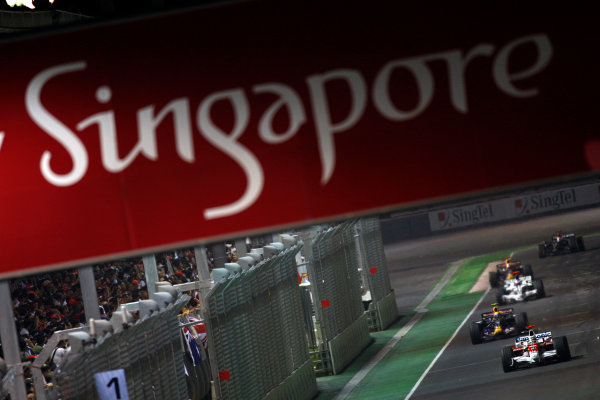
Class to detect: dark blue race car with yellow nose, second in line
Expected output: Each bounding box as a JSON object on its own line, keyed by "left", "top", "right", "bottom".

{"left": 470, "top": 303, "right": 529, "bottom": 344}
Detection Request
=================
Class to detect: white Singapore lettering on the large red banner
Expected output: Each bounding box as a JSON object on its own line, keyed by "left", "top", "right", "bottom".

{"left": 19, "top": 34, "right": 552, "bottom": 219}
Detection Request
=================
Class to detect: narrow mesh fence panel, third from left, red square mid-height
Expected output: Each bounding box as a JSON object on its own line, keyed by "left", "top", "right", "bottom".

{"left": 302, "top": 220, "right": 371, "bottom": 374}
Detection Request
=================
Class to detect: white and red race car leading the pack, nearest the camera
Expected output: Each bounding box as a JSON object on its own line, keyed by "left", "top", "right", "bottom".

{"left": 501, "top": 325, "right": 571, "bottom": 372}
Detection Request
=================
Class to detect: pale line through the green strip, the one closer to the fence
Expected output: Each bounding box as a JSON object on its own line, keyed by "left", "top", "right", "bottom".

{"left": 333, "top": 262, "right": 462, "bottom": 400}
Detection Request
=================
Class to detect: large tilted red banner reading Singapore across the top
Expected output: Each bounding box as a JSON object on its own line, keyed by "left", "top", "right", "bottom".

{"left": 0, "top": 2, "right": 600, "bottom": 275}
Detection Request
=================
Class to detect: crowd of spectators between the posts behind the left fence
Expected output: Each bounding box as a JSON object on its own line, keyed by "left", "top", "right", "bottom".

{"left": 0, "top": 249, "right": 213, "bottom": 361}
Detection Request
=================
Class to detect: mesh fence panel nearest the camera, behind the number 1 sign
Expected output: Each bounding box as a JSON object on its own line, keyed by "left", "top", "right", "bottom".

{"left": 55, "top": 296, "right": 189, "bottom": 400}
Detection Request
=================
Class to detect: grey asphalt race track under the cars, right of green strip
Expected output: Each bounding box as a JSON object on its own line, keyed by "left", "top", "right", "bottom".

{"left": 386, "top": 209, "right": 600, "bottom": 399}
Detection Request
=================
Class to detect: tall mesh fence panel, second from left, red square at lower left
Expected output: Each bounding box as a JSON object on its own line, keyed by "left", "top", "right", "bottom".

{"left": 204, "top": 246, "right": 317, "bottom": 400}
